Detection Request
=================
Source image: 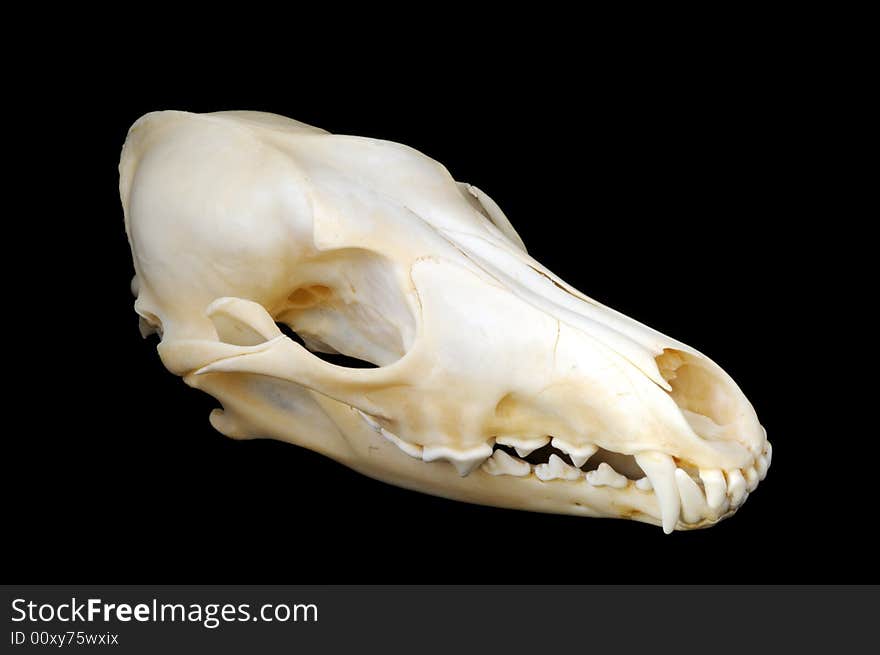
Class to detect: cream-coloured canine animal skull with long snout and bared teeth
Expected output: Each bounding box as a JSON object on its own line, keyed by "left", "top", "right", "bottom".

{"left": 119, "top": 111, "right": 771, "bottom": 532}
